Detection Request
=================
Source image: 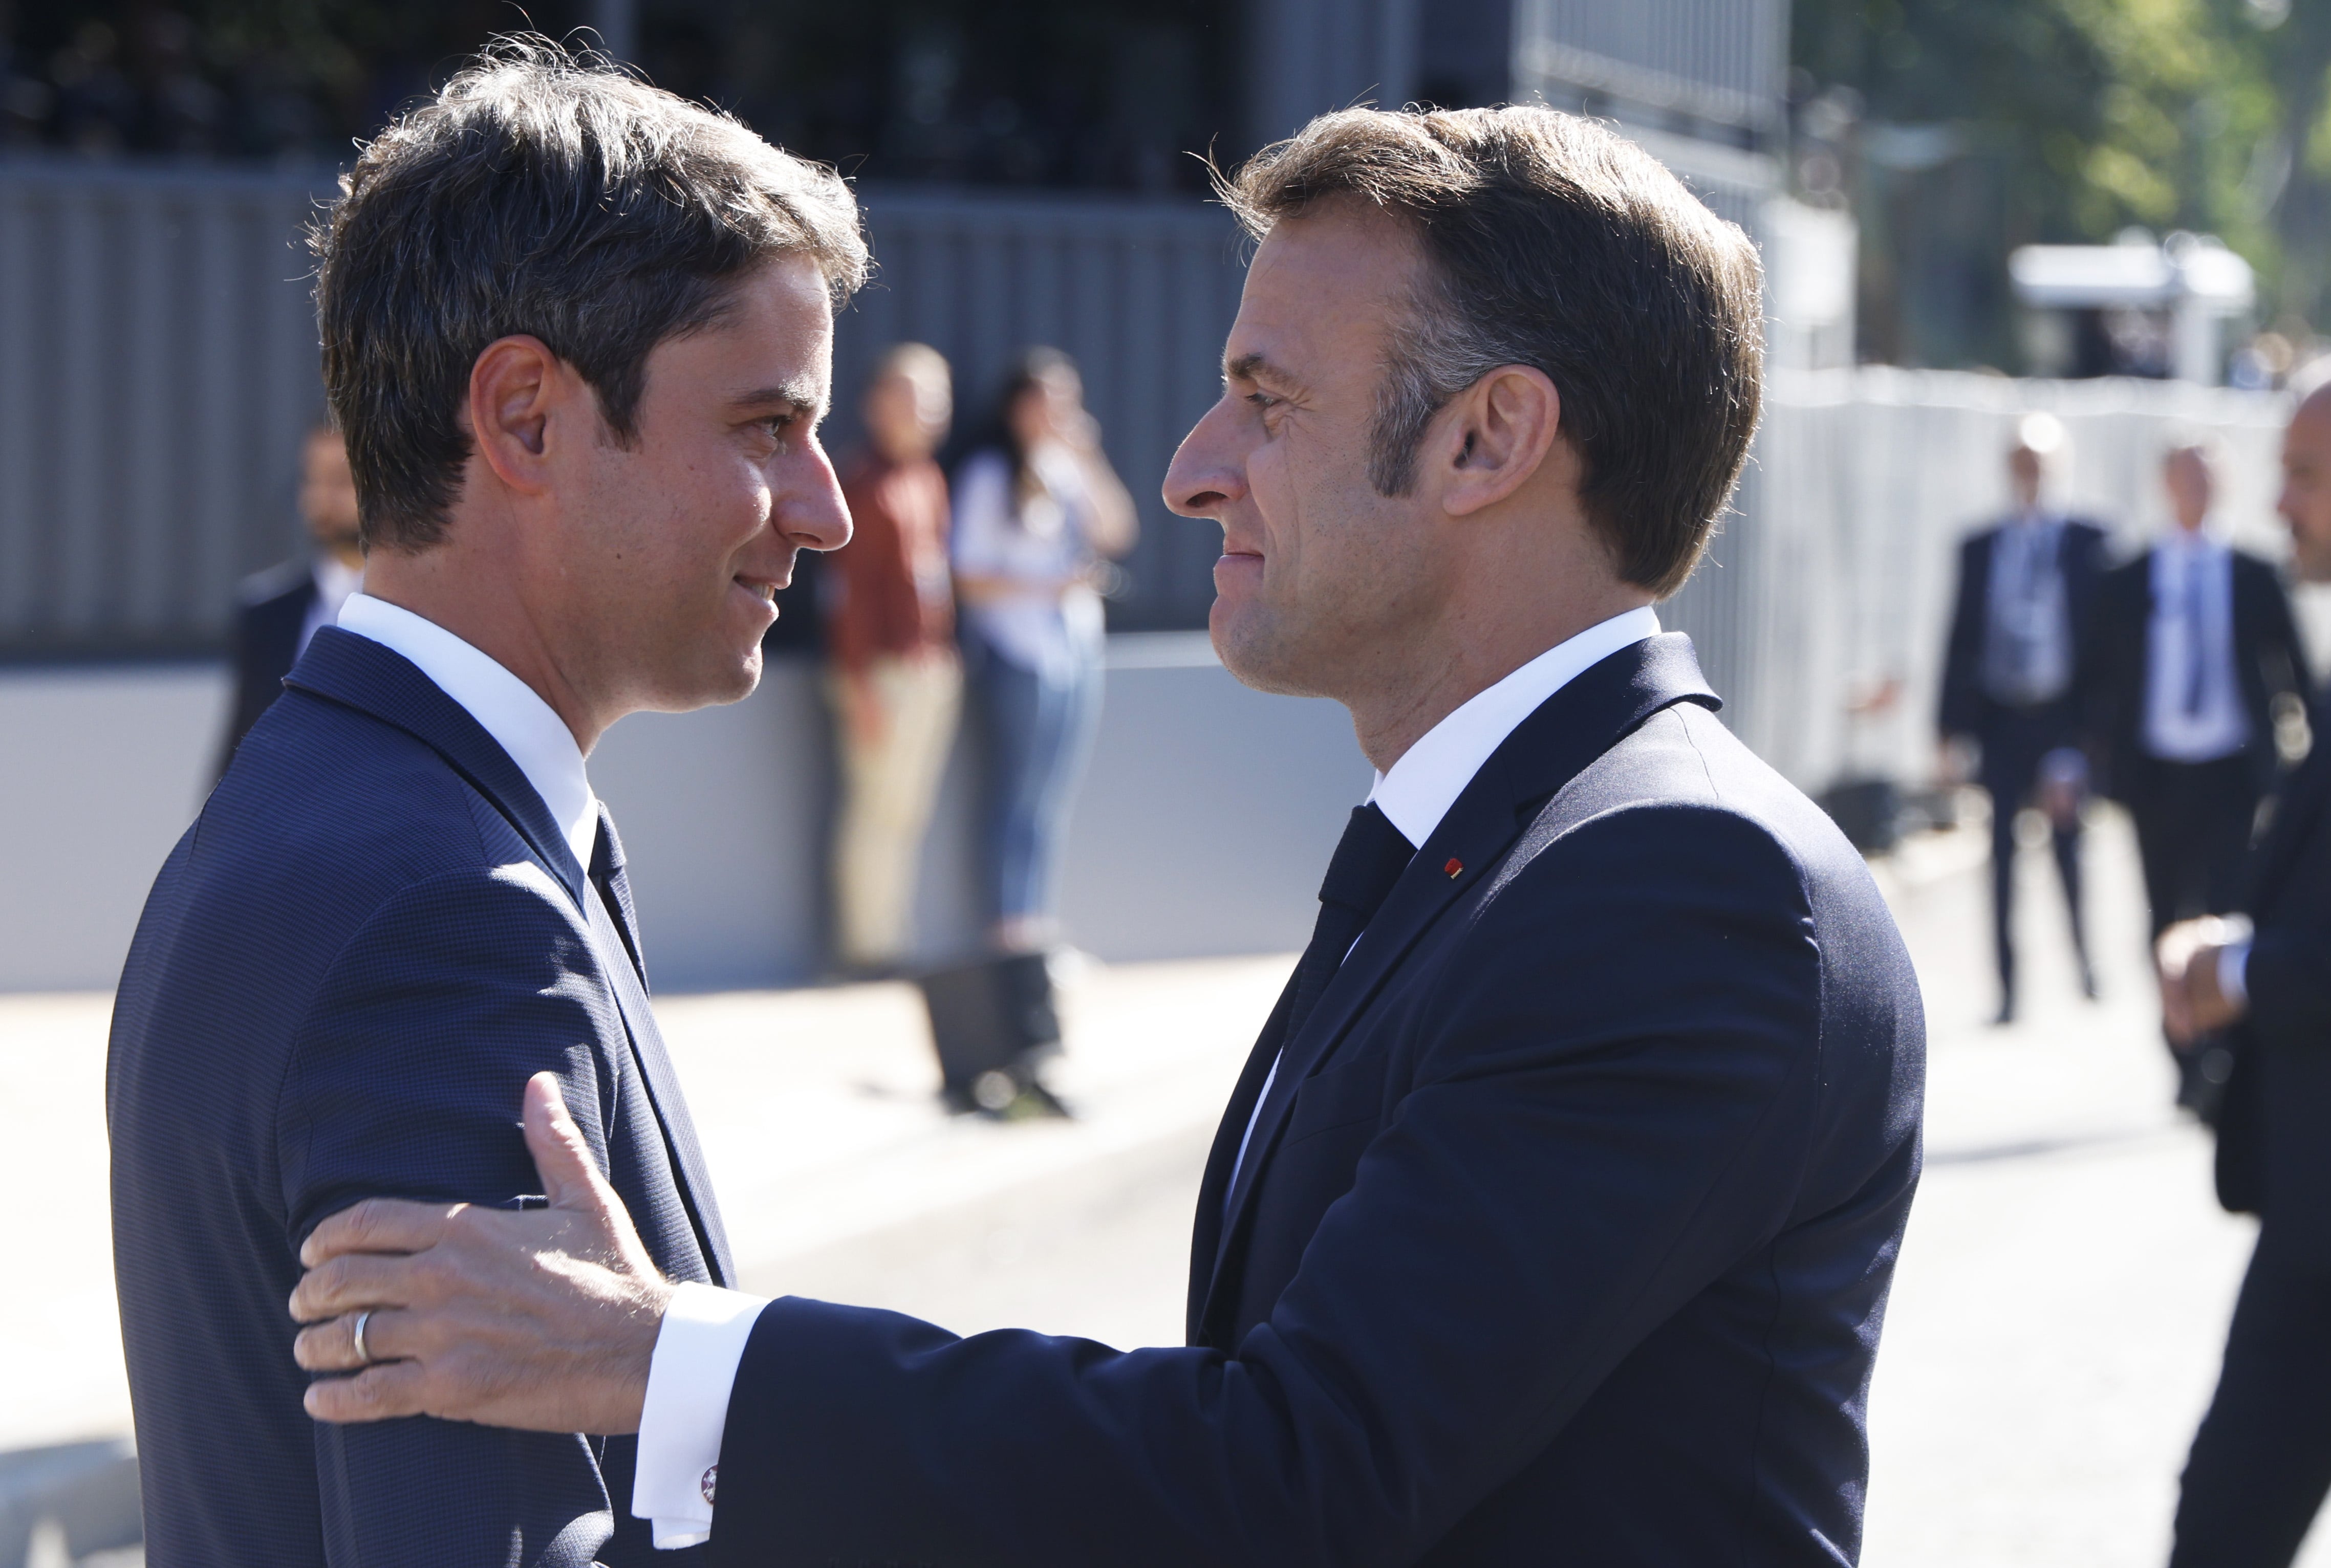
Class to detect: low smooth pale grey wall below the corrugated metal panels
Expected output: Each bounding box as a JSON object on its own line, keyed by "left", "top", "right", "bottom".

{"left": 0, "top": 634, "right": 1368, "bottom": 990}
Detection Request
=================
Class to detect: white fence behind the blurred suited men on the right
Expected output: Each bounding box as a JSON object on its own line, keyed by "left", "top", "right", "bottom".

{"left": 1743, "top": 366, "right": 2286, "bottom": 790}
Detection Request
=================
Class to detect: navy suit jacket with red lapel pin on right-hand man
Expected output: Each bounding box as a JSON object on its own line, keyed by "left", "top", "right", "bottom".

{"left": 711, "top": 636, "right": 1926, "bottom": 1568}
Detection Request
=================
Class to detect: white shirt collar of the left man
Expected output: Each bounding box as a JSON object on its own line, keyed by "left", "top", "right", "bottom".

{"left": 340, "top": 594, "right": 599, "bottom": 872}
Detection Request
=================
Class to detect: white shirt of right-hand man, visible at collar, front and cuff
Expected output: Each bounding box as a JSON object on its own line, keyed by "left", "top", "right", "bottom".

{"left": 632, "top": 606, "right": 1659, "bottom": 1547}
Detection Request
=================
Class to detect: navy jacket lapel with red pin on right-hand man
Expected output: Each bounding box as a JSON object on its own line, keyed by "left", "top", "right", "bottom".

{"left": 1191, "top": 631, "right": 1718, "bottom": 1340}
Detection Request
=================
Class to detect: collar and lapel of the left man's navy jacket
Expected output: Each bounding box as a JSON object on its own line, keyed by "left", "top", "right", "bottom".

{"left": 285, "top": 627, "right": 735, "bottom": 1284}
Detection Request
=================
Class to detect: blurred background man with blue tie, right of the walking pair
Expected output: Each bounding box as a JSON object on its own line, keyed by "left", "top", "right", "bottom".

{"left": 2084, "top": 443, "right": 2305, "bottom": 1118}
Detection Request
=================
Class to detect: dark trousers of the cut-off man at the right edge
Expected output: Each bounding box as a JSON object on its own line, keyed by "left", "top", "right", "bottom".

{"left": 2170, "top": 1226, "right": 2331, "bottom": 1568}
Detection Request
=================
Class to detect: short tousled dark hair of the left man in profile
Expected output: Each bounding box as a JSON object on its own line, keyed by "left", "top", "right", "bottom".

{"left": 310, "top": 37, "right": 867, "bottom": 550}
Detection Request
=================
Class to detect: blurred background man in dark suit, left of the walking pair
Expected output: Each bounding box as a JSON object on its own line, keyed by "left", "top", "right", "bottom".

{"left": 1941, "top": 415, "right": 2105, "bottom": 1023}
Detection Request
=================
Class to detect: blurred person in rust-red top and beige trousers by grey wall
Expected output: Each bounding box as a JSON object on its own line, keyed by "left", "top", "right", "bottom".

{"left": 823, "top": 342, "right": 963, "bottom": 974}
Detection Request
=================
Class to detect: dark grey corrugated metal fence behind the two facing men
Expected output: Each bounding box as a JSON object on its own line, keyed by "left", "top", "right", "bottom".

{"left": 0, "top": 159, "right": 1242, "bottom": 657}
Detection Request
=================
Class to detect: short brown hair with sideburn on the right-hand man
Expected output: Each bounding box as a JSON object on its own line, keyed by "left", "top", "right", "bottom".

{"left": 1219, "top": 107, "right": 1764, "bottom": 597}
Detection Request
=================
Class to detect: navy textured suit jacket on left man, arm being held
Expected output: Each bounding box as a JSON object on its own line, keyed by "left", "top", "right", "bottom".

{"left": 107, "top": 627, "right": 732, "bottom": 1568}
